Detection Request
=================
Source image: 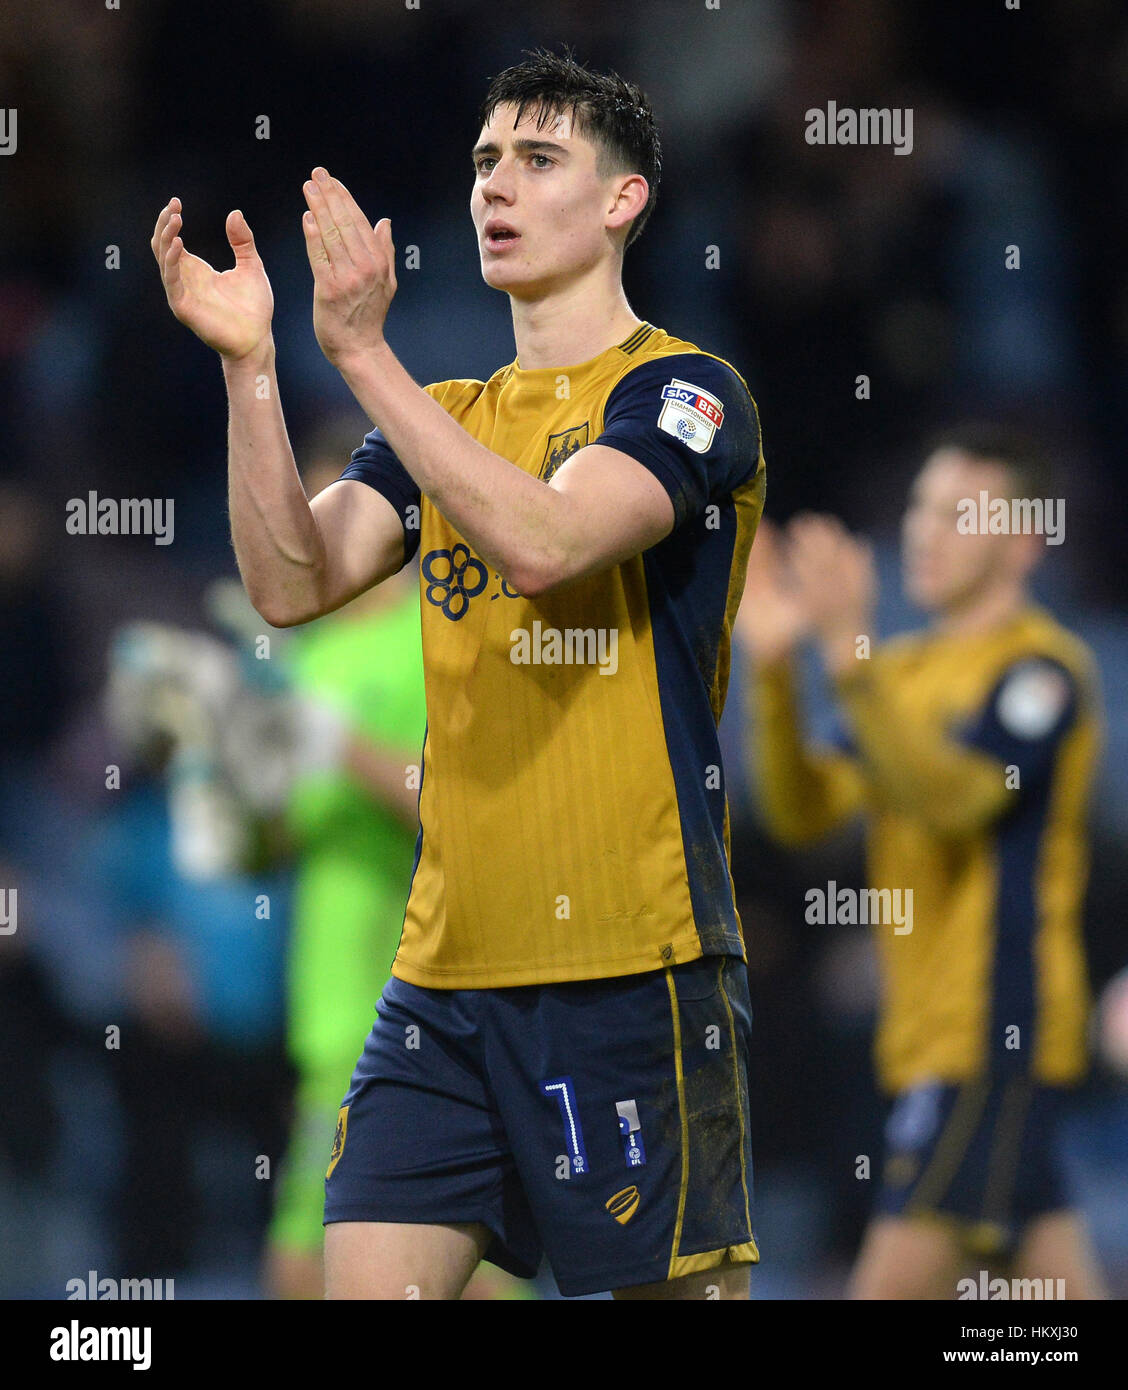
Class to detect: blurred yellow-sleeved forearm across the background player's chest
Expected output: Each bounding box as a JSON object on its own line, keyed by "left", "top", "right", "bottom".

{"left": 835, "top": 660, "right": 1011, "bottom": 834}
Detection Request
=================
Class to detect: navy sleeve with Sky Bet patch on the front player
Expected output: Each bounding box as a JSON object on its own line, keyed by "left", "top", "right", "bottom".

{"left": 595, "top": 353, "right": 760, "bottom": 527}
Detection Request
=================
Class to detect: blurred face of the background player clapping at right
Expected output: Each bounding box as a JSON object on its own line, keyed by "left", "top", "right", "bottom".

{"left": 902, "top": 449, "right": 1022, "bottom": 613}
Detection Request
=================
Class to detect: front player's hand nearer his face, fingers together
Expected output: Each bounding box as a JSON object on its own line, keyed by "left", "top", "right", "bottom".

{"left": 301, "top": 167, "right": 396, "bottom": 367}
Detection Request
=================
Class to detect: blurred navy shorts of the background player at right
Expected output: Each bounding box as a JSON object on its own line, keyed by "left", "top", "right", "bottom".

{"left": 878, "top": 1074, "right": 1070, "bottom": 1255}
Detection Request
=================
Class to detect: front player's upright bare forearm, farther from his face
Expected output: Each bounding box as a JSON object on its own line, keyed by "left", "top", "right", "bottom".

{"left": 224, "top": 343, "right": 332, "bottom": 627}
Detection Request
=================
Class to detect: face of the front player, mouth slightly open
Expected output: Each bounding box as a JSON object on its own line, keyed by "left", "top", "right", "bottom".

{"left": 470, "top": 104, "right": 615, "bottom": 299}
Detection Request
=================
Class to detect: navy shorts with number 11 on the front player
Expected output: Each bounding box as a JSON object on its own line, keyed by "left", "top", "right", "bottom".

{"left": 325, "top": 956, "right": 760, "bottom": 1295}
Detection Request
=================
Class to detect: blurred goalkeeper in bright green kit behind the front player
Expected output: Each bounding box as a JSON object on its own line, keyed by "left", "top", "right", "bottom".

{"left": 267, "top": 423, "right": 426, "bottom": 1298}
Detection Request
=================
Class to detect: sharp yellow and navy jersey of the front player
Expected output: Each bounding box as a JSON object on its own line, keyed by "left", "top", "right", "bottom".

{"left": 342, "top": 324, "right": 764, "bottom": 988}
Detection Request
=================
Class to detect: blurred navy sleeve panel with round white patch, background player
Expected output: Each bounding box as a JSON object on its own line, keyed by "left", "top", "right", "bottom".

{"left": 960, "top": 656, "right": 1079, "bottom": 792}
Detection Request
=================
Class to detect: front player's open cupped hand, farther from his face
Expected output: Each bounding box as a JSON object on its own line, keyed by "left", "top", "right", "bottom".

{"left": 150, "top": 197, "right": 274, "bottom": 360}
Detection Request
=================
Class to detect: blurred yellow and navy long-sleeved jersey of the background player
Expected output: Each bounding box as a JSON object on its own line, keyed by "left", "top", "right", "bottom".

{"left": 752, "top": 607, "right": 1100, "bottom": 1091}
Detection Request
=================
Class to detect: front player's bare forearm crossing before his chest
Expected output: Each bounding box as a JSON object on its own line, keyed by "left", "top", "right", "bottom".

{"left": 336, "top": 343, "right": 569, "bottom": 594}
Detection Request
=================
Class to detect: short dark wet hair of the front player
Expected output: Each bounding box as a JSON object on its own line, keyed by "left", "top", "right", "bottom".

{"left": 478, "top": 49, "right": 661, "bottom": 246}
